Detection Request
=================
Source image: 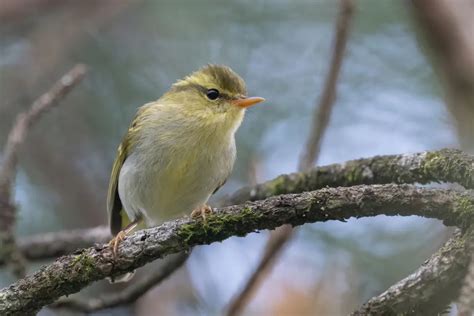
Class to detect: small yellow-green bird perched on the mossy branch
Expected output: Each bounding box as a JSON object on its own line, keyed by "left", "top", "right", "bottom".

{"left": 107, "top": 65, "right": 264, "bottom": 254}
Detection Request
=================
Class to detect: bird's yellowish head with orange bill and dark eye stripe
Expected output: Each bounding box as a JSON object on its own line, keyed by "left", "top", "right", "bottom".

{"left": 164, "top": 65, "right": 265, "bottom": 126}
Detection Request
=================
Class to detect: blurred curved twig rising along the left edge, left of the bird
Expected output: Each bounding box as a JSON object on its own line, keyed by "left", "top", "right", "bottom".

{"left": 0, "top": 64, "right": 86, "bottom": 276}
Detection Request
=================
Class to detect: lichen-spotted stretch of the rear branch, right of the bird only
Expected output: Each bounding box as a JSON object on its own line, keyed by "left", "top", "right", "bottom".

{"left": 226, "top": 149, "right": 474, "bottom": 205}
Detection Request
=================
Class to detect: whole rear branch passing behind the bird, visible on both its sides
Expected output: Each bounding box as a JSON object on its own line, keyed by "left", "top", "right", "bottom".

{"left": 0, "top": 149, "right": 474, "bottom": 265}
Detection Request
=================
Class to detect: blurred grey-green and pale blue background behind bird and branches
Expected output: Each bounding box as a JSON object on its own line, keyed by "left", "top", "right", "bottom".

{"left": 0, "top": 0, "right": 470, "bottom": 315}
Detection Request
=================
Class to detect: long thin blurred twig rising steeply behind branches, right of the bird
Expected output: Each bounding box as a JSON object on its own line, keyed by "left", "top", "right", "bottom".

{"left": 227, "top": 0, "right": 354, "bottom": 316}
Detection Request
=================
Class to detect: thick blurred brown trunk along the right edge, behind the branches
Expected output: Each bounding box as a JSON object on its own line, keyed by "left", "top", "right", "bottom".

{"left": 413, "top": 0, "right": 474, "bottom": 315}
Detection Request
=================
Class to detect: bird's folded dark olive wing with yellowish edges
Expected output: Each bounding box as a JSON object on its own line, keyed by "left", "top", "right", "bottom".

{"left": 107, "top": 103, "right": 151, "bottom": 236}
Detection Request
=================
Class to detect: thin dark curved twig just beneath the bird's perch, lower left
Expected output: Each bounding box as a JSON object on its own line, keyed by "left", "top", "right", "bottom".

{"left": 51, "top": 253, "right": 189, "bottom": 313}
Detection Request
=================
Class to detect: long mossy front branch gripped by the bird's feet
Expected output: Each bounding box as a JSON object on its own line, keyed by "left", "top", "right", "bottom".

{"left": 0, "top": 185, "right": 474, "bottom": 315}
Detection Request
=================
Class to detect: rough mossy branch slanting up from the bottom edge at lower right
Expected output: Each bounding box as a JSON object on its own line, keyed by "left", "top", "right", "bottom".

{"left": 351, "top": 231, "right": 470, "bottom": 316}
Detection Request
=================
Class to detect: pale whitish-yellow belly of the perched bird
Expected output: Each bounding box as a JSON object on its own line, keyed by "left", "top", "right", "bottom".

{"left": 118, "top": 135, "right": 235, "bottom": 226}
